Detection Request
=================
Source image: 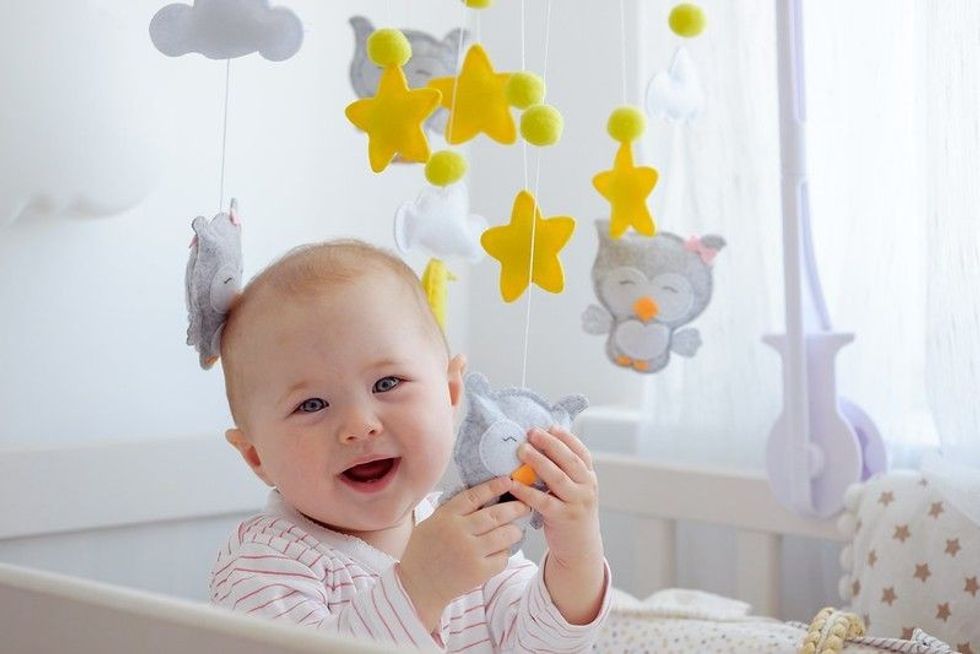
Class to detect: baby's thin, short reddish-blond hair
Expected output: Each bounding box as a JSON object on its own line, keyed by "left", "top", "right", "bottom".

{"left": 221, "top": 239, "right": 449, "bottom": 426}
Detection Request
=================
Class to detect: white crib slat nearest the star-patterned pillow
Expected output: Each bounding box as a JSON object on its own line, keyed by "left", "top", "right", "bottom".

{"left": 735, "top": 530, "right": 783, "bottom": 617}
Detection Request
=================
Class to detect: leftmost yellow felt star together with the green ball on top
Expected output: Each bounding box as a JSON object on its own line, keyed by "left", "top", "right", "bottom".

{"left": 345, "top": 29, "right": 440, "bottom": 173}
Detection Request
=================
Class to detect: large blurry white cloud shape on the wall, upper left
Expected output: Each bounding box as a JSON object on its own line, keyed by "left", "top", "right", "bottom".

{"left": 0, "top": 2, "right": 165, "bottom": 227}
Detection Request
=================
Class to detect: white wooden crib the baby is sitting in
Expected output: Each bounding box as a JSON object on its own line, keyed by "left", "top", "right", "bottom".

{"left": 0, "top": 408, "right": 840, "bottom": 654}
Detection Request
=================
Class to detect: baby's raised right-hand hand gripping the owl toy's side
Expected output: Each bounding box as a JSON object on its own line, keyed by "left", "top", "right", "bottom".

{"left": 510, "top": 425, "right": 603, "bottom": 567}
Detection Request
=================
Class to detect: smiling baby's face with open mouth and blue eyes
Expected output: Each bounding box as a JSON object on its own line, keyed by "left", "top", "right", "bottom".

{"left": 229, "top": 275, "right": 462, "bottom": 532}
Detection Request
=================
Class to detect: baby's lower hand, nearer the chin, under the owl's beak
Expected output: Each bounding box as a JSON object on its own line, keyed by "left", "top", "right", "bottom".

{"left": 398, "top": 477, "right": 530, "bottom": 630}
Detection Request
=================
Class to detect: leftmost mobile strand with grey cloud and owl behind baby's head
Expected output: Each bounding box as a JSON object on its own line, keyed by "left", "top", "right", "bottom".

{"left": 150, "top": 0, "right": 303, "bottom": 370}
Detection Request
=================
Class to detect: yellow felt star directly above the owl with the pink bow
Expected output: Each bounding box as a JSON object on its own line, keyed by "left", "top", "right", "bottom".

{"left": 592, "top": 143, "right": 659, "bottom": 238}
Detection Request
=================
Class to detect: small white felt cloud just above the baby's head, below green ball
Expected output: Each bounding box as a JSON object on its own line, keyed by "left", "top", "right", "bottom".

{"left": 395, "top": 182, "right": 487, "bottom": 262}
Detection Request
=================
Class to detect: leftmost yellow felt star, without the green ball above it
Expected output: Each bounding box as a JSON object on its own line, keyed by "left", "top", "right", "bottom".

{"left": 344, "top": 66, "right": 439, "bottom": 173}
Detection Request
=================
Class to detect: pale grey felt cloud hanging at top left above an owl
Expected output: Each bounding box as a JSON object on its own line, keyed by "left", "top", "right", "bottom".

{"left": 150, "top": 0, "right": 303, "bottom": 61}
